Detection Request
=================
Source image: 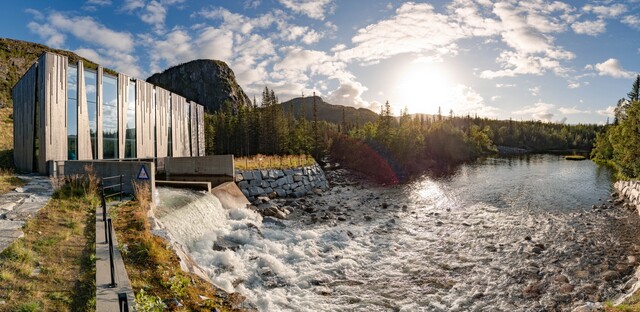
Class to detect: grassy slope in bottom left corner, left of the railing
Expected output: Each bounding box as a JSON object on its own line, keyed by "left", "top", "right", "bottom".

{"left": 0, "top": 178, "right": 99, "bottom": 311}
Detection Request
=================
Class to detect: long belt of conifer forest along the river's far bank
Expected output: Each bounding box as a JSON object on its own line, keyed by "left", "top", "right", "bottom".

{"left": 205, "top": 87, "right": 602, "bottom": 183}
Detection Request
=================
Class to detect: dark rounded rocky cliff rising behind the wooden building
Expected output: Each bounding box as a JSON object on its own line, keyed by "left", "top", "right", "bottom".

{"left": 147, "top": 60, "right": 251, "bottom": 112}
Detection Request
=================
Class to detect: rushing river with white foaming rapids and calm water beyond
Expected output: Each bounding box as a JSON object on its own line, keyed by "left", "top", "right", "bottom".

{"left": 160, "top": 155, "right": 640, "bottom": 311}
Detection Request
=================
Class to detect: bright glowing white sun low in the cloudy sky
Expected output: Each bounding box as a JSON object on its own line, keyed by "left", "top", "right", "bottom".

{"left": 394, "top": 63, "right": 454, "bottom": 114}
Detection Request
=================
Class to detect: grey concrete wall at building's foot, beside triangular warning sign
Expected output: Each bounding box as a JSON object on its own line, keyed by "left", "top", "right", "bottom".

{"left": 50, "top": 160, "right": 156, "bottom": 199}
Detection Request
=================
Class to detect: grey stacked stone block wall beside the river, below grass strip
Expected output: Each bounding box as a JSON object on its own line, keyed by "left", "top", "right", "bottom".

{"left": 236, "top": 164, "right": 329, "bottom": 202}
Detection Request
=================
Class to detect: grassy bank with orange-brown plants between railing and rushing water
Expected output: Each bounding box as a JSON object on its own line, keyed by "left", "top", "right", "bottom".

{"left": 110, "top": 182, "right": 244, "bottom": 311}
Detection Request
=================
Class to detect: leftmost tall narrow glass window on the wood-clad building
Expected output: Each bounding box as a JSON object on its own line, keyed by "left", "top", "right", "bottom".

{"left": 67, "top": 65, "right": 78, "bottom": 160}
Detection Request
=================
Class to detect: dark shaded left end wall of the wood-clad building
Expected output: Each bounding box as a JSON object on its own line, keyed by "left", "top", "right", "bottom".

{"left": 12, "top": 64, "right": 38, "bottom": 172}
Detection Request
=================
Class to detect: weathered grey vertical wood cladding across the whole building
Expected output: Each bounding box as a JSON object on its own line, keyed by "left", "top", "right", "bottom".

{"left": 12, "top": 53, "right": 205, "bottom": 174}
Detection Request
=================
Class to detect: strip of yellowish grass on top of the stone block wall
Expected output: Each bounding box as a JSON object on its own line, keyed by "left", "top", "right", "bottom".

{"left": 234, "top": 155, "right": 316, "bottom": 170}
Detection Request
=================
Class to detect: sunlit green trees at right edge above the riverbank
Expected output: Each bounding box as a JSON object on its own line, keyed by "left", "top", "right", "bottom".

{"left": 591, "top": 75, "right": 640, "bottom": 179}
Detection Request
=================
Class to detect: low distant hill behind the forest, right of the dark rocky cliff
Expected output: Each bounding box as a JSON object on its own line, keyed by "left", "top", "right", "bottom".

{"left": 279, "top": 96, "right": 378, "bottom": 125}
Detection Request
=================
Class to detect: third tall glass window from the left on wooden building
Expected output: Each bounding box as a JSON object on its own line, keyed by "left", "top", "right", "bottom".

{"left": 102, "top": 74, "right": 119, "bottom": 159}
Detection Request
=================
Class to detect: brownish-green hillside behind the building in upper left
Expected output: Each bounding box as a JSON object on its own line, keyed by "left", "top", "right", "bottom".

{"left": 0, "top": 38, "right": 97, "bottom": 107}
